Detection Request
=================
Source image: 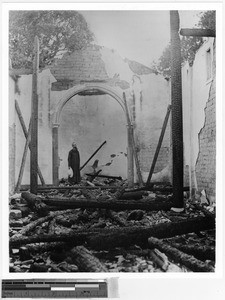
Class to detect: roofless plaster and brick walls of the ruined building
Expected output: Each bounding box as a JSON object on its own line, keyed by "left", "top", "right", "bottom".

{"left": 9, "top": 38, "right": 216, "bottom": 202}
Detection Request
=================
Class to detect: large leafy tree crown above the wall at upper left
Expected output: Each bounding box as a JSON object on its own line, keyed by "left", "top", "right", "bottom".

{"left": 9, "top": 10, "right": 93, "bottom": 68}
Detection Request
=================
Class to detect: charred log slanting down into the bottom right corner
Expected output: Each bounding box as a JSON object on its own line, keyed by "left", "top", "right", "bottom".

{"left": 148, "top": 237, "right": 215, "bottom": 272}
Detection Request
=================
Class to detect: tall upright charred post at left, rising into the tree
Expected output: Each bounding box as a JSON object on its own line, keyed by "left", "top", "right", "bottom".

{"left": 30, "top": 36, "right": 39, "bottom": 194}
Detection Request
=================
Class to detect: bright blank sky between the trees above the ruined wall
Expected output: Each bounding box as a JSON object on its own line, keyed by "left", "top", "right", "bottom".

{"left": 82, "top": 10, "right": 204, "bottom": 66}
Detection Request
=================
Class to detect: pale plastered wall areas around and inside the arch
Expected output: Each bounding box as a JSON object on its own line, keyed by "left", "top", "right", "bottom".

{"left": 9, "top": 51, "right": 170, "bottom": 184}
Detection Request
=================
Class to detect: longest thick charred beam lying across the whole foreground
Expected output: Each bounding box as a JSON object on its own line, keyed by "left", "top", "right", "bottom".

{"left": 9, "top": 217, "right": 215, "bottom": 250}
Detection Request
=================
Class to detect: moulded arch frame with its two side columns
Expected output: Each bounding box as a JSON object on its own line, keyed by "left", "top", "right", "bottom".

{"left": 52, "top": 83, "right": 134, "bottom": 187}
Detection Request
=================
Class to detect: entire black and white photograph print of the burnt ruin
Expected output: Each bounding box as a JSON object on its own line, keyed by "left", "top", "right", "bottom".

{"left": 8, "top": 6, "right": 220, "bottom": 274}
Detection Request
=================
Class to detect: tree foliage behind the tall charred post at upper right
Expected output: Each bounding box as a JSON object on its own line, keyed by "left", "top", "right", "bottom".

{"left": 152, "top": 10, "right": 216, "bottom": 78}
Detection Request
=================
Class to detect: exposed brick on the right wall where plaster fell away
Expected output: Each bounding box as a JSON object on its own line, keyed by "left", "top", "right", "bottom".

{"left": 196, "top": 41, "right": 216, "bottom": 196}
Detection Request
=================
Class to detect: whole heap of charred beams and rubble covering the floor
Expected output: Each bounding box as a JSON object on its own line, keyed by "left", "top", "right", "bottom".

{"left": 9, "top": 179, "right": 215, "bottom": 272}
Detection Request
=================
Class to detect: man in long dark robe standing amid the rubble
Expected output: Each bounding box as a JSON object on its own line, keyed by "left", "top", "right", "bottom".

{"left": 68, "top": 143, "right": 81, "bottom": 184}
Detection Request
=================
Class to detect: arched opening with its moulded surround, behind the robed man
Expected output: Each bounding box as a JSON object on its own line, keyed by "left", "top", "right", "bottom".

{"left": 53, "top": 84, "right": 134, "bottom": 186}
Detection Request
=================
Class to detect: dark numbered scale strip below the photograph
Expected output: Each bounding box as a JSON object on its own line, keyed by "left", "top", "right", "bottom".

{"left": 2, "top": 279, "right": 108, "bottom": 298}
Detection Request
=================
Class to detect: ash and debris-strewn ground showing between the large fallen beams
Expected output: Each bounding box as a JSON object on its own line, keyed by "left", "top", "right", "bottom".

{"left": 9, "top": 180, "right": 215, "bottom": 273}
